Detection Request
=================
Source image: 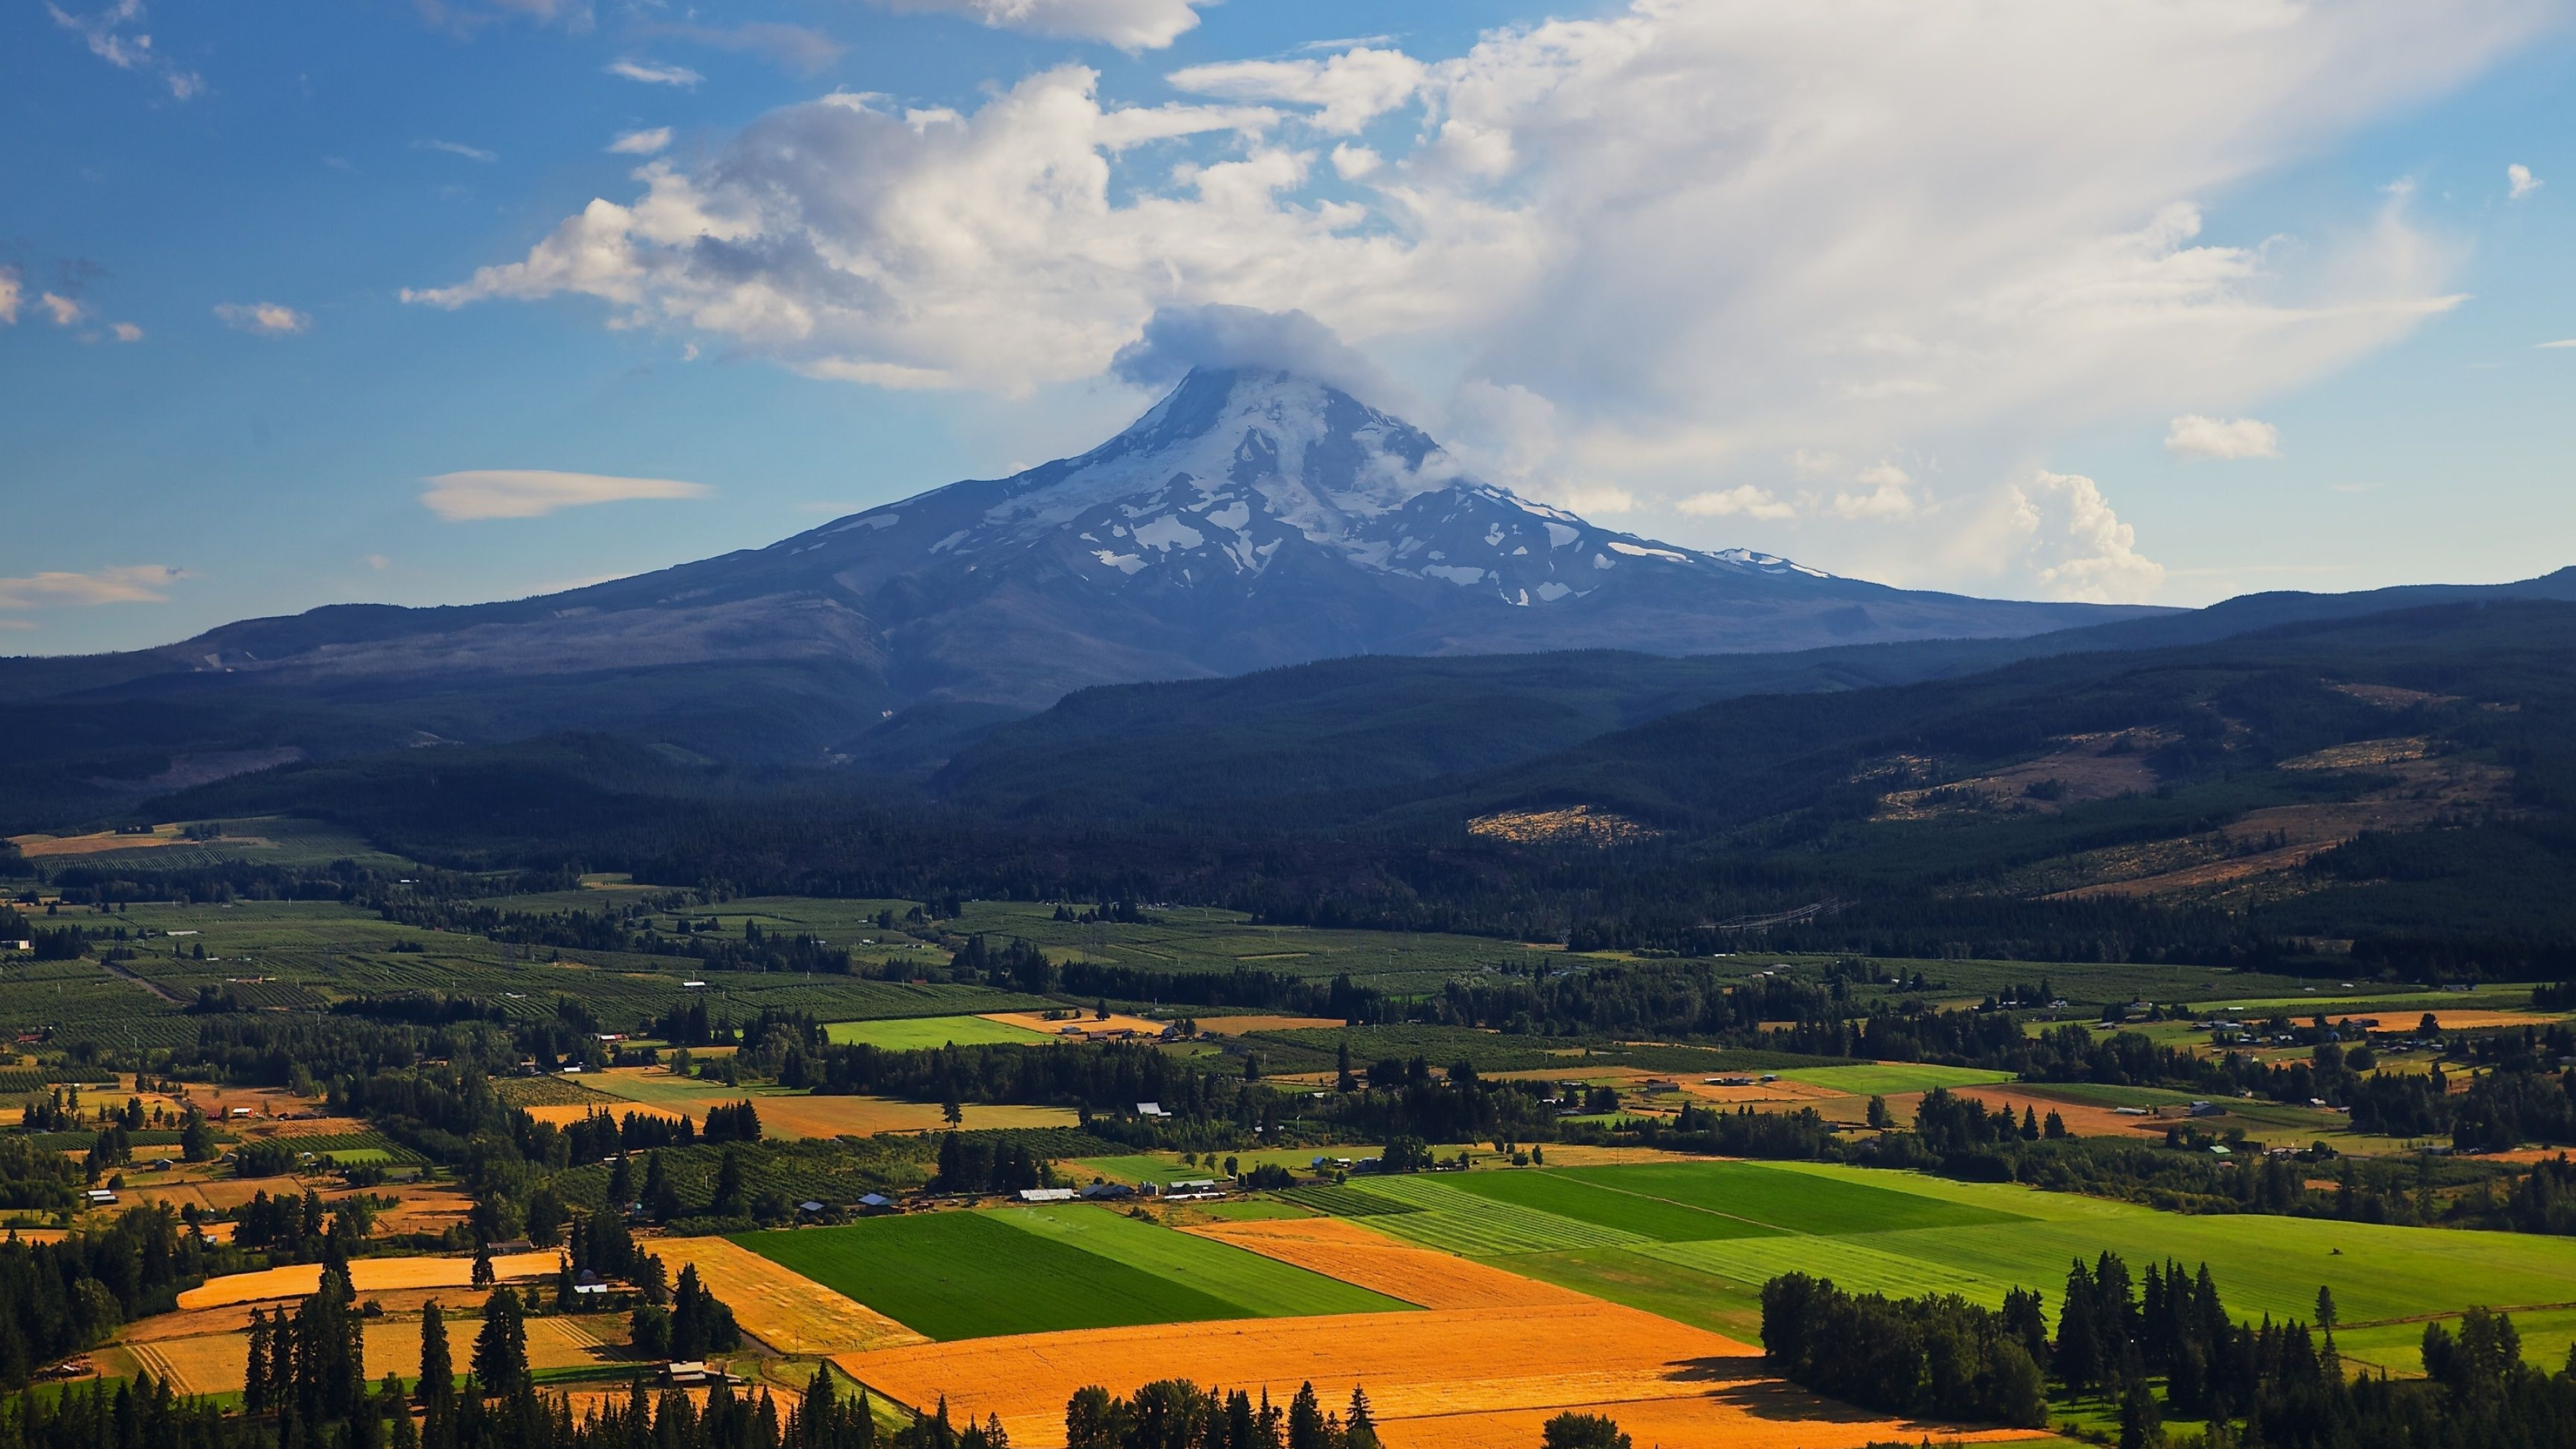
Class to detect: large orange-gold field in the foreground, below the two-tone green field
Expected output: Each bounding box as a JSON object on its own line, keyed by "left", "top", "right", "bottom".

{"left": 835, "top": 1299, "right": 2029, "bottom": 1449}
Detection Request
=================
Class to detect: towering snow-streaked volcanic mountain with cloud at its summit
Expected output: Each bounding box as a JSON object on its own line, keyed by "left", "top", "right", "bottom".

{"left": 136, "top": 371, "right": 2133, "bottom": 724}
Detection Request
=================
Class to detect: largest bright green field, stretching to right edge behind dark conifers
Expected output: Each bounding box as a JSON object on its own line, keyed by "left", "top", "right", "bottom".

{"left": 1296, "top": 1163, "right": 2576, "bottom": 1372}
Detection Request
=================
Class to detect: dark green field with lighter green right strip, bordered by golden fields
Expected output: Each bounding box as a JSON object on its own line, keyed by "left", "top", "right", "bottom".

{"left": 734, "top": 1204, "right": 1407, "bottom": 1341}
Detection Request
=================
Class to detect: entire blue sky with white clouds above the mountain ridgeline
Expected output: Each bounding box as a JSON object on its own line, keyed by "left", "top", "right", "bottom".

{"left": 0, "top": 0, "right": 2576, "bottom": 652}
